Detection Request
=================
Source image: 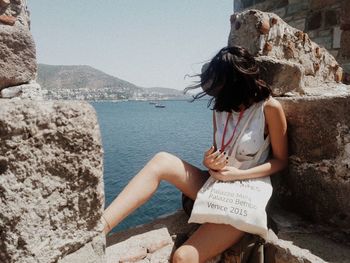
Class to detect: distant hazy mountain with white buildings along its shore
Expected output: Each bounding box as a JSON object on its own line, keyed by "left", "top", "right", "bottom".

{"left": 37, "top": 64, "right": 188, "bottom": 100}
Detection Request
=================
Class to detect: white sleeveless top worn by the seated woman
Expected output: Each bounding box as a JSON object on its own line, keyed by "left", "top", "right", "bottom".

{"left": 214, "top": 101, "right": 270, "bottom": 169}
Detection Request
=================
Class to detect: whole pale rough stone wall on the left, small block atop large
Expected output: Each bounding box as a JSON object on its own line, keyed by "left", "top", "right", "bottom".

{"left": 0, "top": 0, "right": 105, "bottom": 263}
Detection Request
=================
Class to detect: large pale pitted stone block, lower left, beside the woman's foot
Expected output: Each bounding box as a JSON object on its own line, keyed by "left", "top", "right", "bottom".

{"left": 0, "top": 99, "right": 104, "bottom": 263}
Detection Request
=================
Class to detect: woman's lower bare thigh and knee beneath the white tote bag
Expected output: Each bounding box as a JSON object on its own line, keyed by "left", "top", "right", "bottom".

{"left": 172, "top": 223, "right": 245, "bottom": 263}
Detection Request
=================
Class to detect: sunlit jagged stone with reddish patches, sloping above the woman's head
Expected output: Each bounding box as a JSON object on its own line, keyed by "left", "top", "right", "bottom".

{"left": 228, "top": 10, "right": 342, "bottom": 91}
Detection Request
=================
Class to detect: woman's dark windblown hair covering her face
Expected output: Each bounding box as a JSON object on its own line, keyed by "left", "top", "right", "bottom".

{"left": 184, "top": 46, "right": 271, "bottom": 112}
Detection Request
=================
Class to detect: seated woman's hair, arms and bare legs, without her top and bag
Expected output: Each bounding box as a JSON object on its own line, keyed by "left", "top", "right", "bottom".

{"left": 103, "top": 47, "right": 288, "bottom": 263}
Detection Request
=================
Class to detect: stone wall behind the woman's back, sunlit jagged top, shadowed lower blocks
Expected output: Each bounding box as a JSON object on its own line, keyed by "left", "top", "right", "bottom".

{"left": 229, "top": 7, "right": 350, "bottom": 229}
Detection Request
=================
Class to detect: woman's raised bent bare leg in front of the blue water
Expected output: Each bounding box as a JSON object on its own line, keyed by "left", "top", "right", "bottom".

{"left": 103, "top": 152, "right": 209, "bottom": 234}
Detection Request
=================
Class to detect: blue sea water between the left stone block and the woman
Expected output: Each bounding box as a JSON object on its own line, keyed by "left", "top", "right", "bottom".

{"left": 90, "top": 100, "right": 212, "bottom": 232}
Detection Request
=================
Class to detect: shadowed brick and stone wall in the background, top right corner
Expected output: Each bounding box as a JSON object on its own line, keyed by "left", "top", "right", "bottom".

{"left": 234, "top": 0, "right": 350, "bottom": 83}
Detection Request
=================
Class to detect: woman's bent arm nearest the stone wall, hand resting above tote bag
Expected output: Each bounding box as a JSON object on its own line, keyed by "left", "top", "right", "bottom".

{"left": 209, "top": 97, "right": 288, "bottom": 181}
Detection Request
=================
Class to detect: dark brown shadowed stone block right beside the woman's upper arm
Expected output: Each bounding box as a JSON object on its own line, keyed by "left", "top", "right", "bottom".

{"left": 278, "top": 85, "right": 350, "bottom": 162}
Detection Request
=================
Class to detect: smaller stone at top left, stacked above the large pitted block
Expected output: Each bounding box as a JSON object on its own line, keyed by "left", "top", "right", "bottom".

{"left": 0, "top": 0, "right": 37, "bottom": 90}
